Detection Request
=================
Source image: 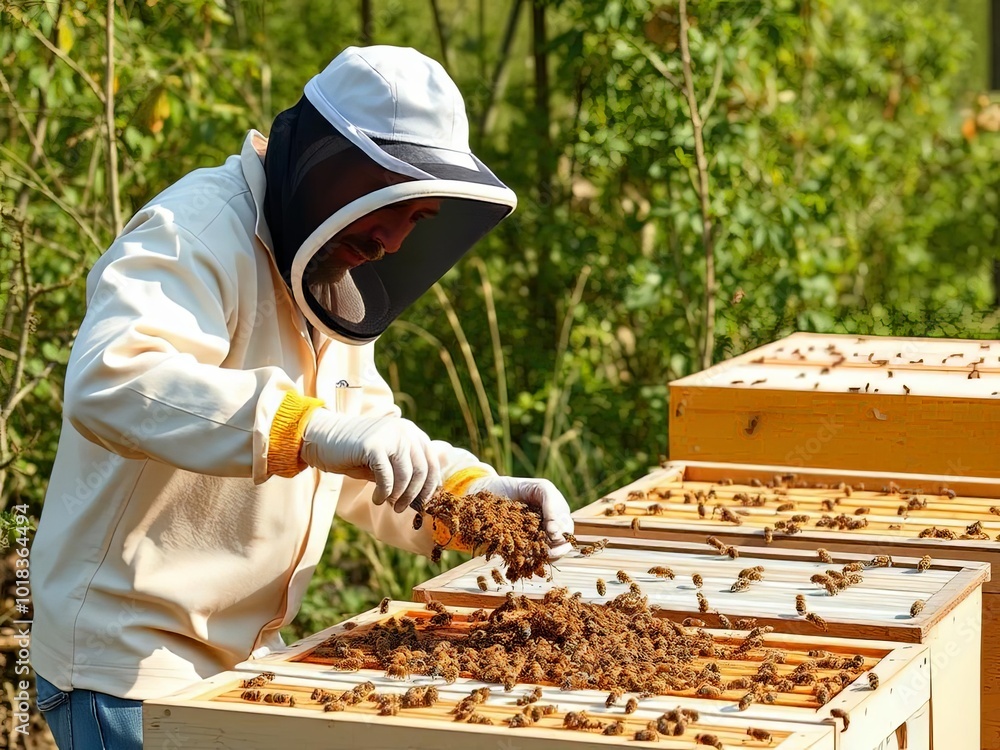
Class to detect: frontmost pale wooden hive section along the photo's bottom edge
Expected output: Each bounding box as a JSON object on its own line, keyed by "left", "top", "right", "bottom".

{"left": 143, "top": 671, "right": 840, "bottom": 750}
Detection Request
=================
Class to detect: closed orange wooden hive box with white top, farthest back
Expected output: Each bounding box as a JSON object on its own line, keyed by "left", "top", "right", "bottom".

{"left": 670, "top": 333, "right": 1000, "bottom": 477}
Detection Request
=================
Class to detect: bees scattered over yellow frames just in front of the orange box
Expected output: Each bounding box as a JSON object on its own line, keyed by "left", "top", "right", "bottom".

{"left": 602, "top": 473, "right": 1000, "bottom": 544}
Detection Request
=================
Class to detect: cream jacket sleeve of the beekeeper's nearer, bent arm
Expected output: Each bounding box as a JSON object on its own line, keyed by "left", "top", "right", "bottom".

{"left": 64, "top": 211, "right": 295, "bottom": 482}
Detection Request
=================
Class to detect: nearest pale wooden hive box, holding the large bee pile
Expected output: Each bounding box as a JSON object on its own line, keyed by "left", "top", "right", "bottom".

{"left": 203, "top": 602, "right": 930, "bottom": 750}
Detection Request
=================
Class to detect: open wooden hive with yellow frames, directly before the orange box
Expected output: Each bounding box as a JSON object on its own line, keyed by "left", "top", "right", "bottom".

{"left": 574, "top": 461, "right": 1000, "bottom": 749}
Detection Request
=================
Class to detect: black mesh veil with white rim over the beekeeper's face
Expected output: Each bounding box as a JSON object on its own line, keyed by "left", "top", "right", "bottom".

{"left": 264, "top": 98, "right": 515, "bottom": 344}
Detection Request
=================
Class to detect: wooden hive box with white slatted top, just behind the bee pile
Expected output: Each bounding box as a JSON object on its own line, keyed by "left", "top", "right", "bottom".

{"left": 413, "top": 536, "right": 990, "bottom": 750}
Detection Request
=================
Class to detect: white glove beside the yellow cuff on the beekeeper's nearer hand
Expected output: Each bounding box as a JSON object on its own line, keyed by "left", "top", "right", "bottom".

{"left": 299, "top": 409, "right": 441, "bottom": 513}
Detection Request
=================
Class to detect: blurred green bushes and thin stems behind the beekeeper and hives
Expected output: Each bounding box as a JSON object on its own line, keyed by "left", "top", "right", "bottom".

{"left": 0, "top": 0, "right": 1000, "bottom": 688}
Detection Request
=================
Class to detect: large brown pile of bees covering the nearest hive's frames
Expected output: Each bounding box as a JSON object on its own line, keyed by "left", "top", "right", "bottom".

{"left": 282, "top": 584, "right": 877, "bottom": 745}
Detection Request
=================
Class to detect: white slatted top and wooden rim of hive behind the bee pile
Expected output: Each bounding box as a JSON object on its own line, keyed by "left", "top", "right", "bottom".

{"left": 413, "top": 535, "right": 990, "bottom": 643}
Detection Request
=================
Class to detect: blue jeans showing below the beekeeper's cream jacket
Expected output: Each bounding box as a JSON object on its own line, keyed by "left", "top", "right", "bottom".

{"left": 35, "top": 674, "right": 142, "bottom": 750}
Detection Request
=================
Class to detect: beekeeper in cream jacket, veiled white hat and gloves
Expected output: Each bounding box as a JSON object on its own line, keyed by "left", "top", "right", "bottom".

{"left": 31, "top": 47, "right": 572, "bottom": 750}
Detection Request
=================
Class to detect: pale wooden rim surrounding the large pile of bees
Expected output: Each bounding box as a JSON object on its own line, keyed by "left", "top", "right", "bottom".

{"left": 225, "top": 602, "right": 930, "bottom": 750}
